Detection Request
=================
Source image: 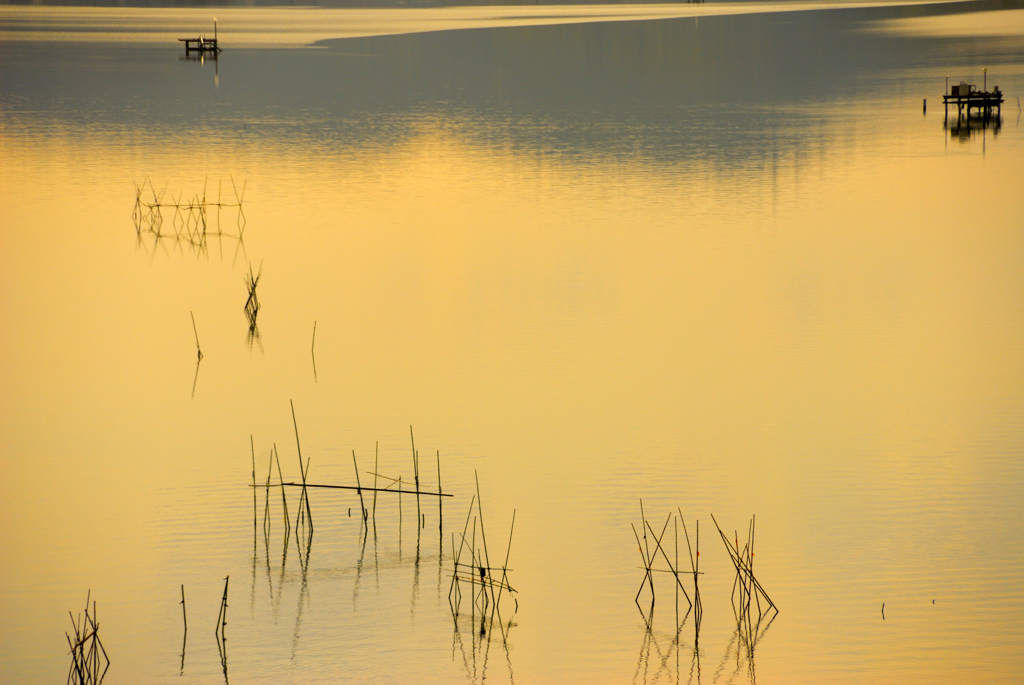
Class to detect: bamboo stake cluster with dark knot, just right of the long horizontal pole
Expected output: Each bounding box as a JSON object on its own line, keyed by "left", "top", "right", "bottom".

{"left": 449, "top": 473, "right": 519, "bottom": 631}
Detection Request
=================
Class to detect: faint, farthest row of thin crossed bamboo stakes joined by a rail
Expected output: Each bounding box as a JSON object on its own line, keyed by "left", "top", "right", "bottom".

{"left": 132, "top": 177, "right": 246, "bottom": 248}
